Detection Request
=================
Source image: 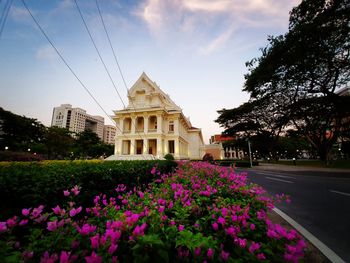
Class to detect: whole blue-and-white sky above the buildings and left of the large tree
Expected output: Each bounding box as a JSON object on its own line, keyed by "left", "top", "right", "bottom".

{"left": 0, "top": 0, "right": 300, "bottom": 143}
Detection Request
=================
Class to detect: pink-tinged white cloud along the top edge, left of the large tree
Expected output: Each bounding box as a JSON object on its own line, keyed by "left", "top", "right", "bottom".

{"left": 135, "top": 0, "right": 300, "bottom": 55}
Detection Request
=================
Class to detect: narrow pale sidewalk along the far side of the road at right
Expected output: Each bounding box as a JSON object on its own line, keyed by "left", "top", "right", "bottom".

{"left": 252, "top": 163, "right": 350, "bottom": 176}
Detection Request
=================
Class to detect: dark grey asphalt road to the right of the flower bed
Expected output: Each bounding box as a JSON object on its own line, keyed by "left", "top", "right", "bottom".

{"left": 242, "top": 168, "right": 350, "bottom": 262}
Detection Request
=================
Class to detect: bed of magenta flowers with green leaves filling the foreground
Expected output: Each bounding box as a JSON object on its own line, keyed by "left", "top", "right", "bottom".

{"left": 0, "top": 162, "right": 305, "bottom": 262}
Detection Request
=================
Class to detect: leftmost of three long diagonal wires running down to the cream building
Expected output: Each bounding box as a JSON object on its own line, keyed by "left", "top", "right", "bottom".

{"left": 21, "top": 0, "right": 138, "bottom": 157}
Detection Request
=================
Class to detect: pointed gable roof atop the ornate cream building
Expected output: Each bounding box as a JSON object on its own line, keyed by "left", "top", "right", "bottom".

{"left": 127, "top": 72, "right": 181, "bottom": 111}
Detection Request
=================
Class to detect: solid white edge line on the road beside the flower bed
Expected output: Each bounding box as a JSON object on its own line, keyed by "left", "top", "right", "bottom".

{"left": 273, "top": 207, "right": 345, "bottom": 263}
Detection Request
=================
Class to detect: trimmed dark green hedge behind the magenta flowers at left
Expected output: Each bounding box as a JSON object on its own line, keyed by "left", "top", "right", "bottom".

{"left": 0, "top": 161, "right": 177, "bottom": 219}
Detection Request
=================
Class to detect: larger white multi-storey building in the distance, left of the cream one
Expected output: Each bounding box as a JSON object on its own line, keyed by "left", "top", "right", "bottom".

{"left": 51, "top": 104, "right": 104, "bottom": 140}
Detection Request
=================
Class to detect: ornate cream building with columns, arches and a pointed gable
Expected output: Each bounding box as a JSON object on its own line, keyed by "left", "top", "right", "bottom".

{"left": 112, "top": 73, "right": 204, "bottom": 159}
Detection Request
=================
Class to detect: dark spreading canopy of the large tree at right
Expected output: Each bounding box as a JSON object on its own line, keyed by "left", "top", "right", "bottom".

{"left": 216, "top": 0, "right": 350, "bottom": 163}
